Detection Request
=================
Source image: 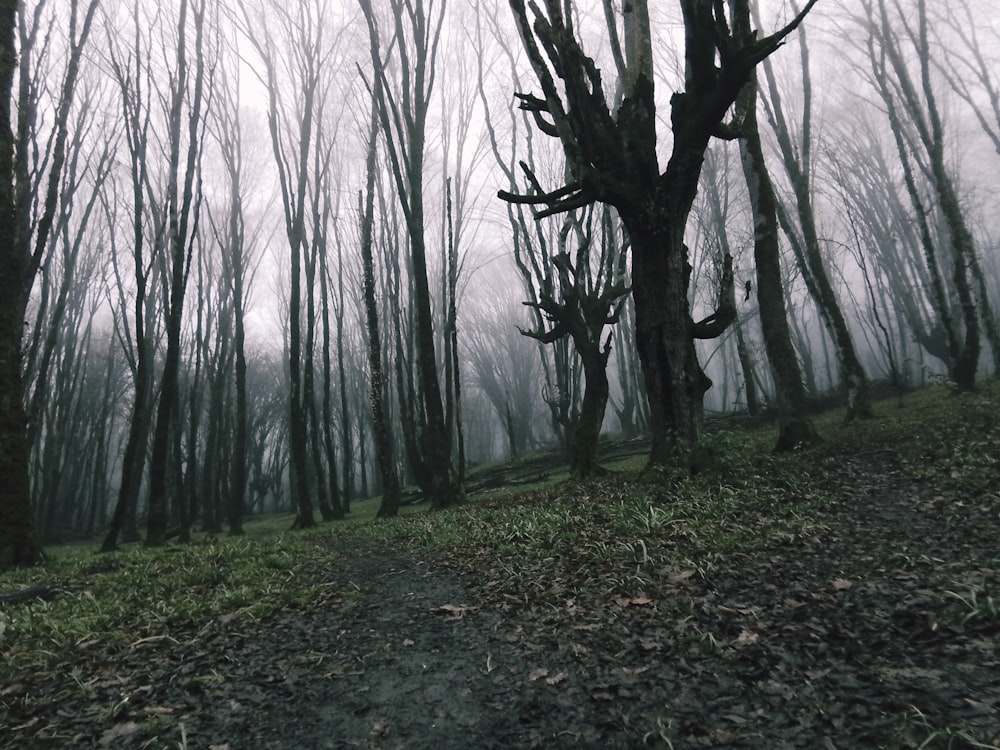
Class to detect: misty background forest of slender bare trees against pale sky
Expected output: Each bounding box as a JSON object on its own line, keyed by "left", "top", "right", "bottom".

{"left": 0, "top": 0, "right": 1000, "bottom": 564}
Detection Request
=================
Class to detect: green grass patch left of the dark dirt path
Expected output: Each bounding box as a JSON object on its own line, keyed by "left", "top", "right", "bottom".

{"left": 0, "top": 535, "right": 336, "bottom": 683}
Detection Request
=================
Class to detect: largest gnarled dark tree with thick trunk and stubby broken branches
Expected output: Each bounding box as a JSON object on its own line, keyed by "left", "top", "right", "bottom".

{"left": 501, "top": 0, "right": 815, "bottom": 469}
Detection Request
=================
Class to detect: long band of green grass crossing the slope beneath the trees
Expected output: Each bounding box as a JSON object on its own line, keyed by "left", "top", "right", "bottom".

{"left": 0, "top": 382, "right": 1000, "bottom": 700}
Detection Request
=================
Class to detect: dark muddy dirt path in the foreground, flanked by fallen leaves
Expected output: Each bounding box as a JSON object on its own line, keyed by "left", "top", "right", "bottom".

{"left": 192, "top": 546, "right": 540, "bottom": 750}
